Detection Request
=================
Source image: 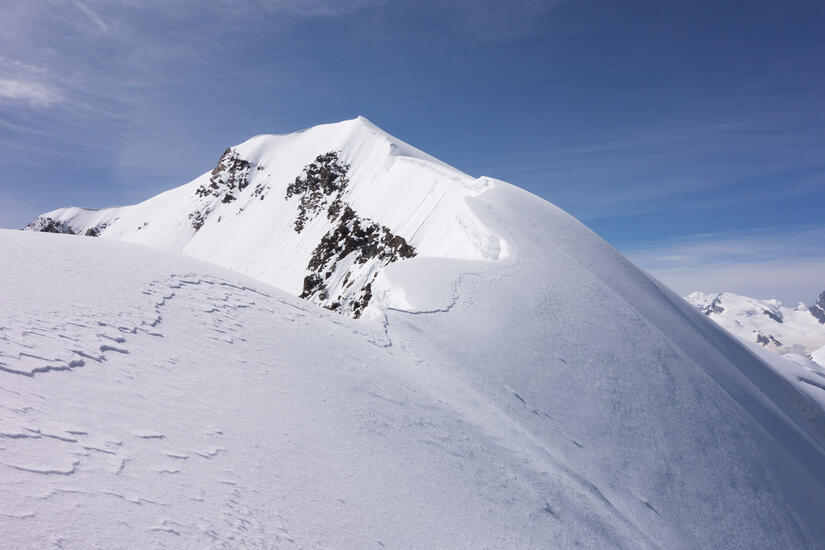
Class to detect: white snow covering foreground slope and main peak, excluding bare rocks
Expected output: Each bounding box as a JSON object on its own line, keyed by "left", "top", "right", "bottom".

{"left": 0, "top": 120, "right": 825, "bottom": 548}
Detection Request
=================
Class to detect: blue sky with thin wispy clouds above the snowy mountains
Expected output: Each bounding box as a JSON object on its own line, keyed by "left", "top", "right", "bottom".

{"left": 0, "top": 0, "right": 825, "bottom": 303}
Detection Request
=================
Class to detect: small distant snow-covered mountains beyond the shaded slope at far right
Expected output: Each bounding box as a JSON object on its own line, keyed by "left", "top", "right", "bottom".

{"left": 685, "top": 292, "right": 825, "bottom": 367}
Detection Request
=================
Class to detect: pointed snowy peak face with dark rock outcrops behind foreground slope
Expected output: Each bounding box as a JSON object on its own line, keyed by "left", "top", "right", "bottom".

{"left": 26, "top": 117, "right": 507, "bottom": 318}
